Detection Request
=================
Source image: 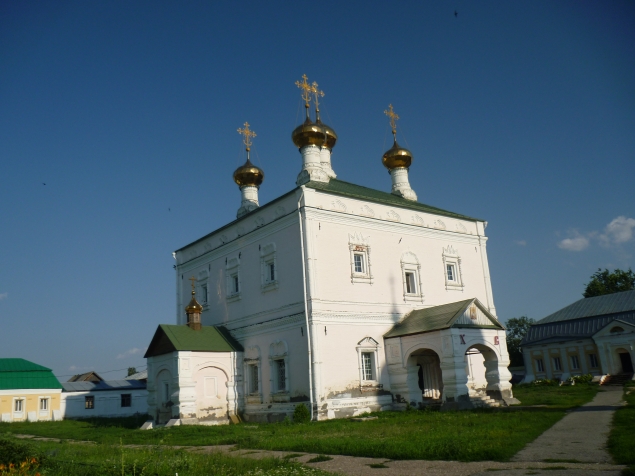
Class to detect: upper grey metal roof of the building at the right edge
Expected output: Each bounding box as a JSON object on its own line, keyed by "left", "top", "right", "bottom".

{"left": 534, "top": 291, "right": 635, "bottom": 325}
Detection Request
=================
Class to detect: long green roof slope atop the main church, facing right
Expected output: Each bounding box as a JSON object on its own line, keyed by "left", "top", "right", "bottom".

{"left": 306, "top": 179, "right": 483, "bottom": 221}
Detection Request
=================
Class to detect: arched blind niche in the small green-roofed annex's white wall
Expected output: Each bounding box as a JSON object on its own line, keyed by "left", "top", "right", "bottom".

{"left": 195, "top": 366, "right": 229, "bottom": 424}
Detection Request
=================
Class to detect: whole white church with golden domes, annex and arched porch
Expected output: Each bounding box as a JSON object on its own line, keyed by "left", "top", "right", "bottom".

{"left": 146, "top": 76, "right": 515, "bottom": 424}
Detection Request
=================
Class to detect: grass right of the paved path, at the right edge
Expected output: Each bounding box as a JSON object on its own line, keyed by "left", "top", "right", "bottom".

{"left": 608, "top": 382, "right": 635, "bottom": 475}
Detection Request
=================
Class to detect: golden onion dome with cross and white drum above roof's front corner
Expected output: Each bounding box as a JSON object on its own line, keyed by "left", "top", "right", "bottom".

{"left": 291, "top": 74, "right": 337, "bottom": 185}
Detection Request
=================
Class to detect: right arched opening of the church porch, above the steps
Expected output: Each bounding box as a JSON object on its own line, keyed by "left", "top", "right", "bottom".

{"left": 465, "top": 344, "right": 502, "bottom": 403}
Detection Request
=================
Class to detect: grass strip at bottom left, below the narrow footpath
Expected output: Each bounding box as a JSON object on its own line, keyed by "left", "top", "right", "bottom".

{"left": 0, "top": 441, "right": 330, "bottom": 476}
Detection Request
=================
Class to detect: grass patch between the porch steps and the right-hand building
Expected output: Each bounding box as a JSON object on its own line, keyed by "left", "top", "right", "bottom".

{"left": 513, "top": 384, "right": 600, "bottom": 408}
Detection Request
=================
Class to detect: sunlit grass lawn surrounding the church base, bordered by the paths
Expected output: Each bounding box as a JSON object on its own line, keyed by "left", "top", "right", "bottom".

{"left": 0, "top": 385, "right": 597, "bottom": 461}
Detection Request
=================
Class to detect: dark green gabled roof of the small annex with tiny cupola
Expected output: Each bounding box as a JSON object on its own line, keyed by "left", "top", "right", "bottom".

{"left": 144, "top": 324, "right": 243, "bottom": 358}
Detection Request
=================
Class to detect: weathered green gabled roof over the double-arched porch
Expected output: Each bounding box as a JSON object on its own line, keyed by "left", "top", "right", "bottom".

{"left": 384, "top": 298, "right": 504, "bottom": 339}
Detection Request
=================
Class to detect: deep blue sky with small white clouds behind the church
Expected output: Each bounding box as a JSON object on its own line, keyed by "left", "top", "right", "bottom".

{"left": 0, "top": 0, "right": 635, "bottom": 379}
